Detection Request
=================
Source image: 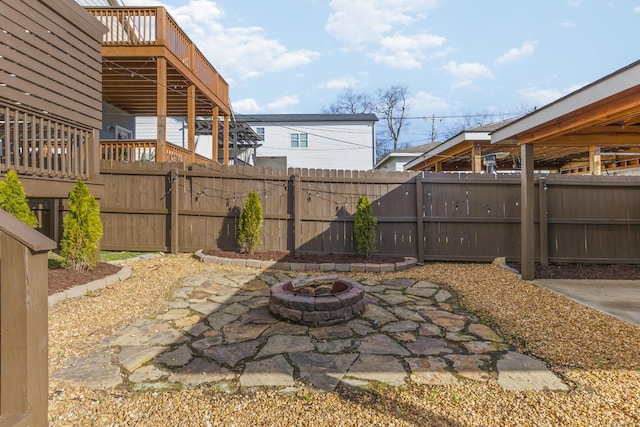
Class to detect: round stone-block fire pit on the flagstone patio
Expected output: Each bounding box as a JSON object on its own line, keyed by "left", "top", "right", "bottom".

{"left": 269, "top": 276, "right": 364, "bottom": 326}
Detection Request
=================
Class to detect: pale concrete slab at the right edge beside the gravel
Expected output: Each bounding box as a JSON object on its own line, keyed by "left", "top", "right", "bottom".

{"left": 531, "top": 279, "right": 640, "bottom": 326}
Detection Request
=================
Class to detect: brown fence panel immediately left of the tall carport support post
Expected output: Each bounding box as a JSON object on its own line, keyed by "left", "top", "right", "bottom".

{"left": 423, "top": 173, "right": 520, "bottom": 261}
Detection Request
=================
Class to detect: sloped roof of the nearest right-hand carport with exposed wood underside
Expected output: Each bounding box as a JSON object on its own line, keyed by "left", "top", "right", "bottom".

{"left": 491, "top": 61, "right": 640, "bottom": 174}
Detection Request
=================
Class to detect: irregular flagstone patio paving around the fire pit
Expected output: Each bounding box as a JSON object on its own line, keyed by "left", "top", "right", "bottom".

{"left": 52, "top": 269, "right": 567, "bottom": 391}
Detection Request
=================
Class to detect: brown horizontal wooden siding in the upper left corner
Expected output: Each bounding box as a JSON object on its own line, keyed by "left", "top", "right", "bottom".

{"left": 0, "top": 0, "right": 105, "bottom": 129}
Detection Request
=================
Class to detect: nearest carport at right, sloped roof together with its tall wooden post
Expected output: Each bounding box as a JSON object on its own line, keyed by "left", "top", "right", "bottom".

{"left": 491, "top": 61, "right": 640, "bottom": 280}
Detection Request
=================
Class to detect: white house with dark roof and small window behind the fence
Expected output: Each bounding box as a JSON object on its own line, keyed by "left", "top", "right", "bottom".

{"left": 235, "top": 114, "right": 378, "bottom": 170}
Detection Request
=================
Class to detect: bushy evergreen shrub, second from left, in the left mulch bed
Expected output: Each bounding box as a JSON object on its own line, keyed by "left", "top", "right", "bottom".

{"left": 60, "top": 178, "right": 102, "bottom": 271}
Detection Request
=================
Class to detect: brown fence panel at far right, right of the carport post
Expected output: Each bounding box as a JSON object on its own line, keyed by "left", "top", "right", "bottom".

{"left": 546, "top": 176, "right": 640, "bottom": 263}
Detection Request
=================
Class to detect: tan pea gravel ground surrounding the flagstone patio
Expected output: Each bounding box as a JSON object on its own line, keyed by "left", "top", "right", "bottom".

{"left": 49, "top": 255, "right": 640, "bottom": 426}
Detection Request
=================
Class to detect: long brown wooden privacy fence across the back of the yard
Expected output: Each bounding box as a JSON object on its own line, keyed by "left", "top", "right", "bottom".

{"left": 96, "top": 162, "right": 640, "bottom": 263}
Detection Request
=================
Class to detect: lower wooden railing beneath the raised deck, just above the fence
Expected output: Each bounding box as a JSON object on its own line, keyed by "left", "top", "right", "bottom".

{"left": 100, "top": 139, "right": 216, "bottom": 164}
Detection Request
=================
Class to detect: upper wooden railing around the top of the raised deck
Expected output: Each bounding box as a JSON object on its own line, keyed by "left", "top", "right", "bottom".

{"left": 87, "top": 7, "right": 229, "bottom": 100}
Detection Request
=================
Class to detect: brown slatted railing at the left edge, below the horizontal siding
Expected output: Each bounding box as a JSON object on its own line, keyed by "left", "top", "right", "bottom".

{"left": 0, "top": 104, "right": 94, "bottom": 180}
